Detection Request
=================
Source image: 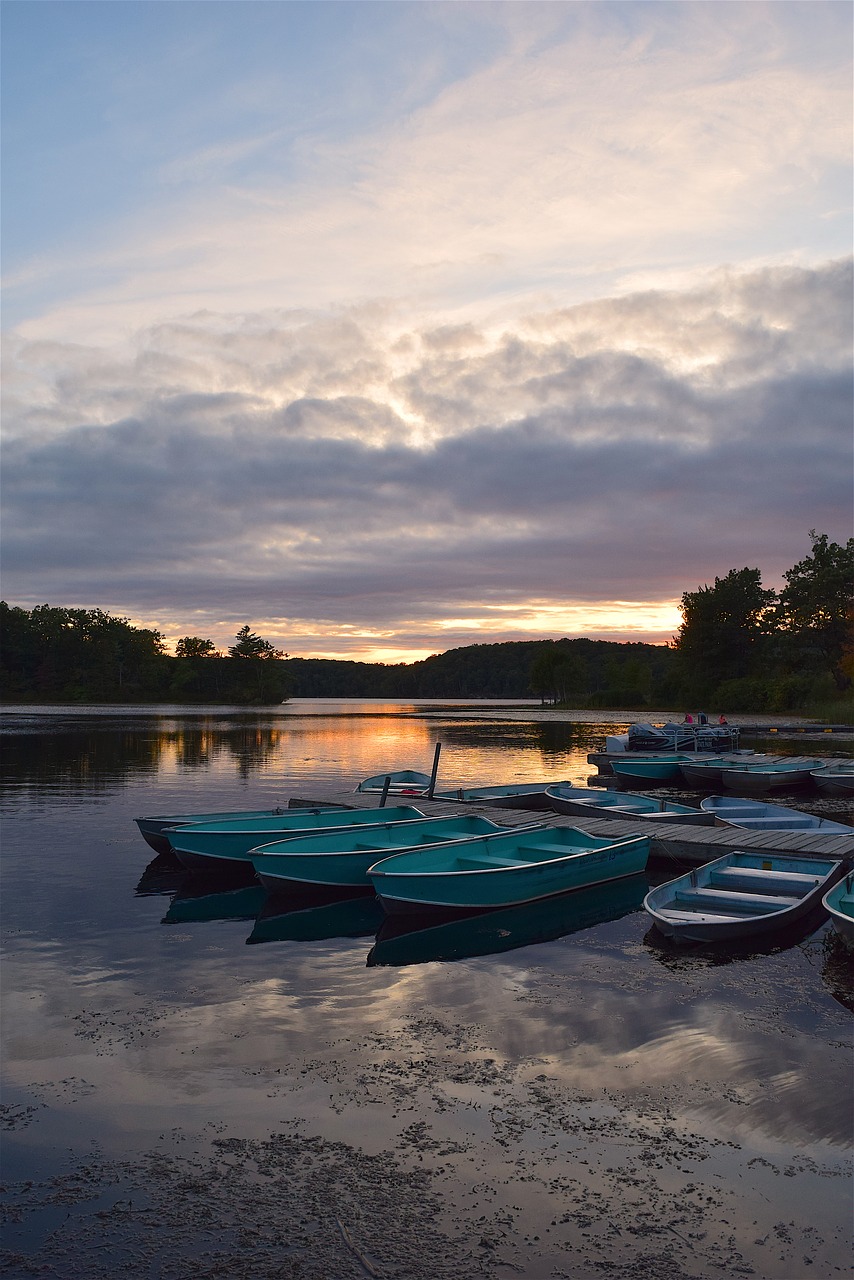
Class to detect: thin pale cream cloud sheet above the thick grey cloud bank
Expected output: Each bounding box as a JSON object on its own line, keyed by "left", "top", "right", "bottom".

{"left": 6, "top": 4, "right": 851, "bottom": 344}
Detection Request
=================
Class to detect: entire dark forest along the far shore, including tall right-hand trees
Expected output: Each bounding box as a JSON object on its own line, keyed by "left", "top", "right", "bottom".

{"left": 0, "top": 530, "right": 854, "bottom": 713}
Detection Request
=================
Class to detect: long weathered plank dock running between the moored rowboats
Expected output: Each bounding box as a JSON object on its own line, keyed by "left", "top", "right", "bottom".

{"left": 289, "top": 788, "right": 854, "bottom": 867}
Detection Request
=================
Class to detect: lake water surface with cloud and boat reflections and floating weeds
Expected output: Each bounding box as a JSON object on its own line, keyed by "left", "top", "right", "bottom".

{"left": 1, "top": 701, "right": 854, "bottom": 1280}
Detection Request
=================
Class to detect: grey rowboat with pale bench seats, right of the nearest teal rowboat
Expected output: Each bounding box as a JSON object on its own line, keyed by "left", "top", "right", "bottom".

{"left": 644, "top": 851, "right": 845, "bottom": 943}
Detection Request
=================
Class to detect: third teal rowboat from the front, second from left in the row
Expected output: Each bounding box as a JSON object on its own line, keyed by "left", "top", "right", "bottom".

{"left": 168, "top": 805, "right": 424, "bottom": 872}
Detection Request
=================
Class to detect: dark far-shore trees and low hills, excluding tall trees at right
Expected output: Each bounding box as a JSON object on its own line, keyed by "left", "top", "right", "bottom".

{"left": 0, "top": 602, "right": 672, "bottom": 707}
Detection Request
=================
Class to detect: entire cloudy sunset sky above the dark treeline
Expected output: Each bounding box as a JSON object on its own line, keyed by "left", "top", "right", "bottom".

{"left": 0, "top": 0, "right": 854, "bottom": 662}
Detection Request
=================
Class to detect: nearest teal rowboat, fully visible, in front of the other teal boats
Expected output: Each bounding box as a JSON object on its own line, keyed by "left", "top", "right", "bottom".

{"left": 367, "top": 827, "right": 649, "bottom": 914}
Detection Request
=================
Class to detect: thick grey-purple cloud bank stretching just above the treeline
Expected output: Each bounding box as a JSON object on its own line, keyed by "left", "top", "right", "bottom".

{"left": 3, "top": 262, "right": 851, "bottom": 653}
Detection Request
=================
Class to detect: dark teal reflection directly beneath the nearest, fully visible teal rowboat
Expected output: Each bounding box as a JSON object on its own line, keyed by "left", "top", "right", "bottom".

{"left": 367, "top": 876, "right": 649, "bottom": 965}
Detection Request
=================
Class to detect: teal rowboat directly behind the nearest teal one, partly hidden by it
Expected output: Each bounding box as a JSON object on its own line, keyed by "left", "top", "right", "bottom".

{"left": 250, "top": 813, "right": 506, "bottom": 893}
